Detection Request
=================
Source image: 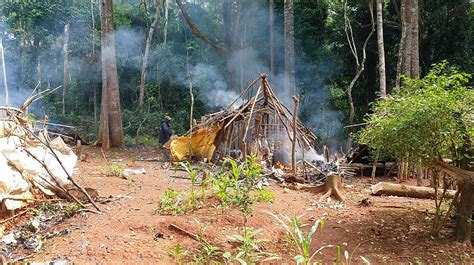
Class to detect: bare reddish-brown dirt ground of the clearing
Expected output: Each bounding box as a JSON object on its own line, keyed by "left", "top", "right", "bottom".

{"left": 4, "top": 147, "right": 474, "bottom": 264}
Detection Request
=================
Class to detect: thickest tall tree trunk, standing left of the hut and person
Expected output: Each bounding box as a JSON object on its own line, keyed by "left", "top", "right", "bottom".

{"left": 99, "top": 0, "right": 123, "bottom": 149}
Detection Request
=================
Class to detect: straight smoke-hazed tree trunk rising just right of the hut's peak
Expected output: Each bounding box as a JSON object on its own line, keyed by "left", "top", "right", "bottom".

{"left": 284, "top": 0, "right": 297, "bottom": 97}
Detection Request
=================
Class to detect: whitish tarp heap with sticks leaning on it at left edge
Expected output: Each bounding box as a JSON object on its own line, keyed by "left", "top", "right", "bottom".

{"left": 0, "top": 90, "right": 100, "bottom": 211}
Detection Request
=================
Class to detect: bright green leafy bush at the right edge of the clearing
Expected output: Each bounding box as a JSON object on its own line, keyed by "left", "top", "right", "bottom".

{"left": 357, "top": 62, "right": 474, "bottom": 166}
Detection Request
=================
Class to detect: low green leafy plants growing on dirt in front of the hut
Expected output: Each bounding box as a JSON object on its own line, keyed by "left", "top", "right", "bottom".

{"left": 156, "top": 156, "right": 275, "bottom": 215}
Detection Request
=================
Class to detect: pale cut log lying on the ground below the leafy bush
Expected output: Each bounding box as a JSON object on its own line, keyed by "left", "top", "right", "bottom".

{"left": 371, "top": 182, "right": 456, "bottom": 199}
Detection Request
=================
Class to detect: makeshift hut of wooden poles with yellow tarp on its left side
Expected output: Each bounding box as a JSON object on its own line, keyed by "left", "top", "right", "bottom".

{"left": 170, "top": 74, "right": 316, "bottom": 163}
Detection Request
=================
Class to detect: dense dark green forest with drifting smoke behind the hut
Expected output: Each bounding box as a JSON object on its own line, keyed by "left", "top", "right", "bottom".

{"left": 0, "top": 0, "right": 474, "bottom": 146}
